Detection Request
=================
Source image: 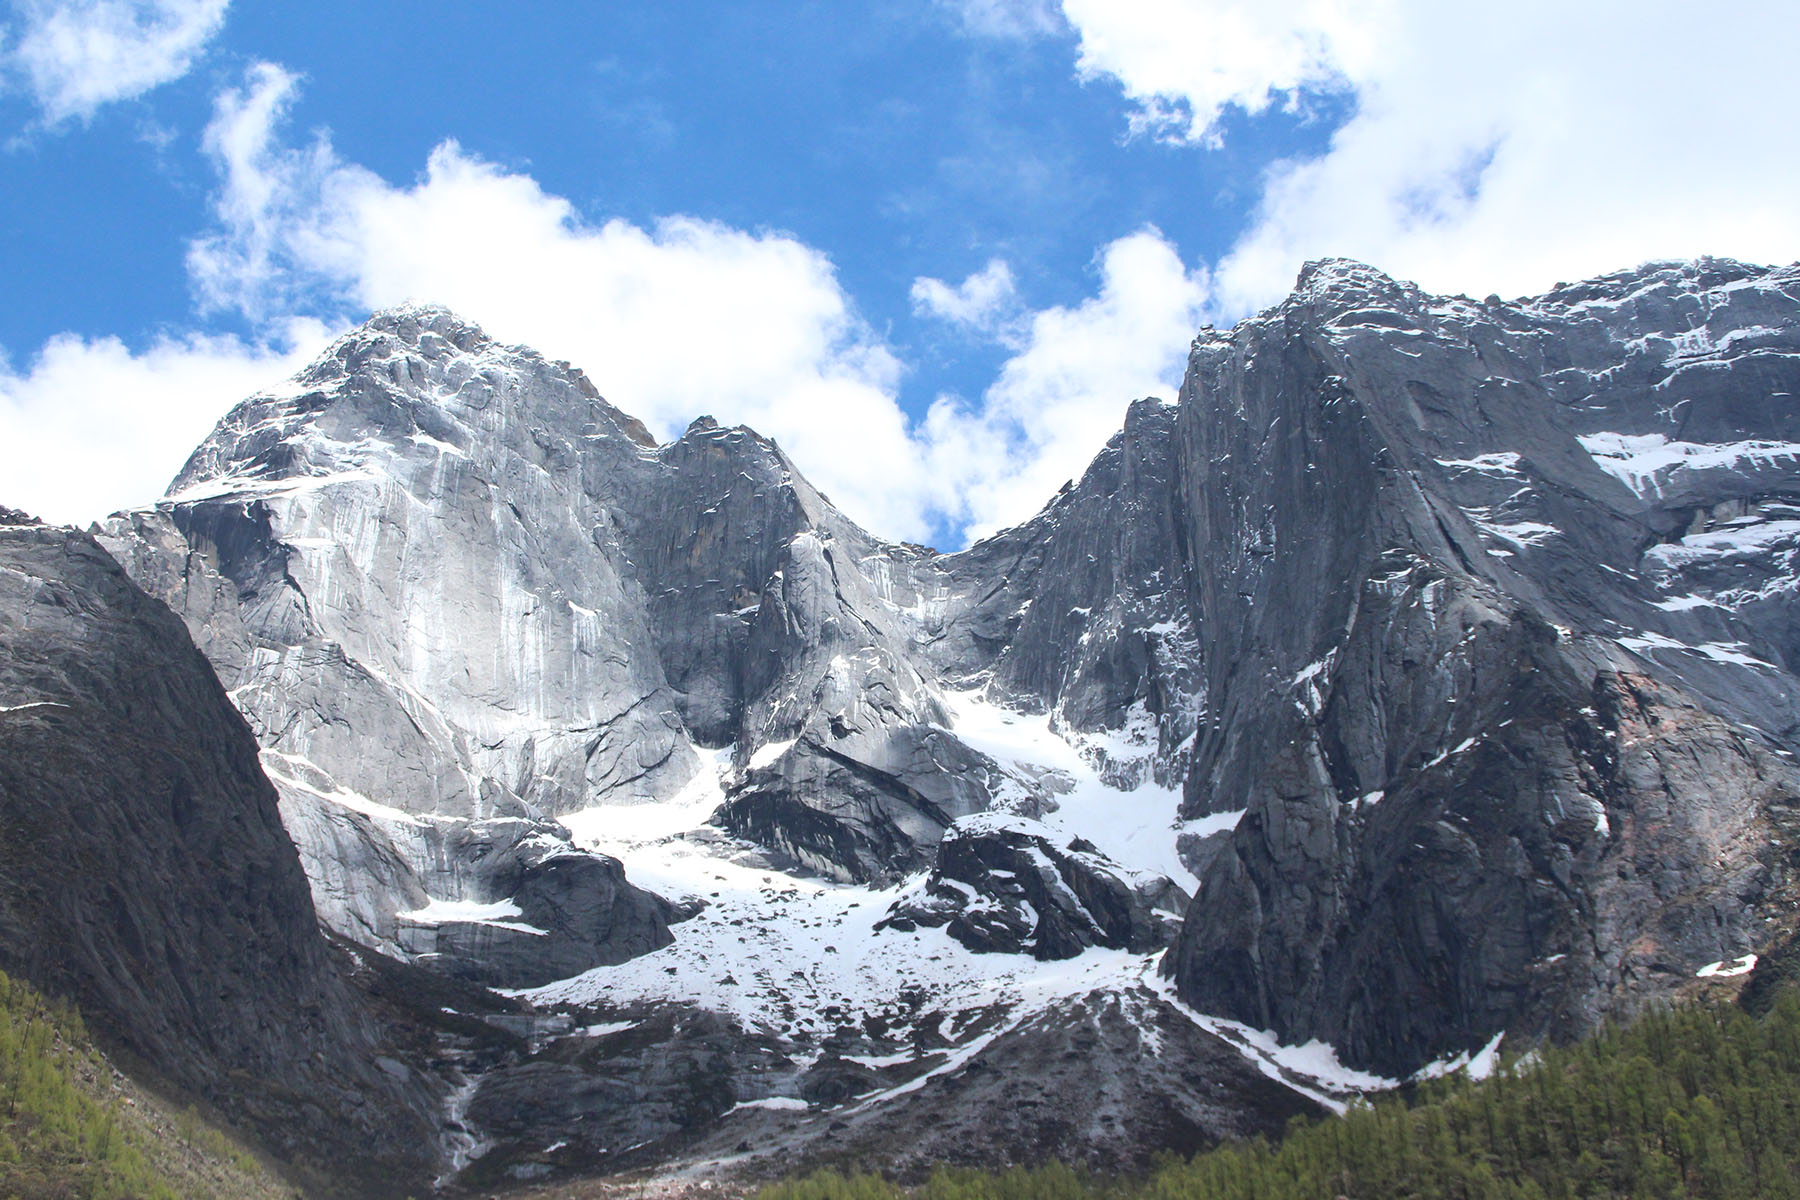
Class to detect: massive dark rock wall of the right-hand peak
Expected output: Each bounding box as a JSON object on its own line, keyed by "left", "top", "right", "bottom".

{"left": 1174, "top": 263, "right": 1800, "bottom": 1074}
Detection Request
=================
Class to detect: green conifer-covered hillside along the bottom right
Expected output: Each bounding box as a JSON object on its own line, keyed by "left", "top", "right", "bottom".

{"left": 758, "top": 988, "right": 1800, "bottom": 1200}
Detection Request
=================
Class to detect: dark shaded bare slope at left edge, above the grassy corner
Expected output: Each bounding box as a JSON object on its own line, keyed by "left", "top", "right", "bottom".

{"left": 0, "top": 511, "right": 436, "bottom": 1195}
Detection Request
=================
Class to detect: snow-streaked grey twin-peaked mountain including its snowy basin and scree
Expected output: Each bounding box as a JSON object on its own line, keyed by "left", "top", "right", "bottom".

{"left": 52, "top": 259, "right": 1800, "bottom": 1182}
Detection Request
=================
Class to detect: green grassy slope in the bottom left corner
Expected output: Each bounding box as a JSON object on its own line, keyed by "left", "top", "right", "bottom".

{"left": 0, "top": 973, "right": 297, "bottom": 1200}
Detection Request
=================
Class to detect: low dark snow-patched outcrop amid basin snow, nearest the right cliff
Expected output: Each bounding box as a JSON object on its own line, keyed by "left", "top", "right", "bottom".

{"left": 877, "top": 817, "right": 1188, "bottom": 959}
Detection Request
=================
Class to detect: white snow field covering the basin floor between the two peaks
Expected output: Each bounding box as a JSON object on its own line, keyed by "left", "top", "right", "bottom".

{"left": 515, "top": 693, "right": 1492, "bottom": 1108}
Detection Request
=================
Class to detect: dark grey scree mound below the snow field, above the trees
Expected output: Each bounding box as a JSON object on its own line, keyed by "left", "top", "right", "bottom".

{"left": 658, "top": 988, "right": 1325, "bottom": 1184}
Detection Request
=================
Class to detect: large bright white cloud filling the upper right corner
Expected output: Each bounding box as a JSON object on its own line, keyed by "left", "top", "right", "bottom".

{"left": 1062, "top": 0, "right": 1800, "bottom": 313}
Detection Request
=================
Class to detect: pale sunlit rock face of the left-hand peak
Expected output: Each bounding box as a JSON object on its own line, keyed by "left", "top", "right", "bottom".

{"left": 103, "top": 311, "right": 695, "bottom": 984}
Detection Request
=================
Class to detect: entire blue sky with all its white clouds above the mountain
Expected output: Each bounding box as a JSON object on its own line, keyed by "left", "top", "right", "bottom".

{"left": 0, "top": 0, "right": 1800, "bottom": 545}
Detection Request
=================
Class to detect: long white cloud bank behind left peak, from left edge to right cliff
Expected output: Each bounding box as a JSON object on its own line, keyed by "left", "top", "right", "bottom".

{"left": 0, "top": 63, "right": 1206, "bottom": 540}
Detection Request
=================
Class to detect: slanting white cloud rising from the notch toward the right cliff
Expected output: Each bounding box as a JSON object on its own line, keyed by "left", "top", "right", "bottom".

{"left": 922, "top": 228, "right": 1208, "bottom": 536}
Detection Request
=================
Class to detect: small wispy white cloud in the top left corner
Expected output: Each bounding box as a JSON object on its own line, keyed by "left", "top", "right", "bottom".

{"left": 4, "top": 0, "right": 230, "bottom": 124}
